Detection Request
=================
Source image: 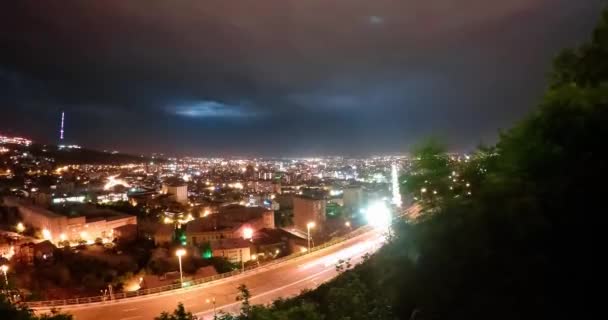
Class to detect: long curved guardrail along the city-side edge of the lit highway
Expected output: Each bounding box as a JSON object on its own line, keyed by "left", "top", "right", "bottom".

{"left": 24, "top": 226, "right": 371, "bottom": 309}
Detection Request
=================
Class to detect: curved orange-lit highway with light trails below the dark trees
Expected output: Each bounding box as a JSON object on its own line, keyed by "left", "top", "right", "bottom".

{"left": 48, "top": 230, "right": 384, "bottom": 320}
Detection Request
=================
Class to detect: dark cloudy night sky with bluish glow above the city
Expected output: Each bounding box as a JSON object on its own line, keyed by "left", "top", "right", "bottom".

{"left": 0, "top": 0, "right": 602, "bottom": 156}
